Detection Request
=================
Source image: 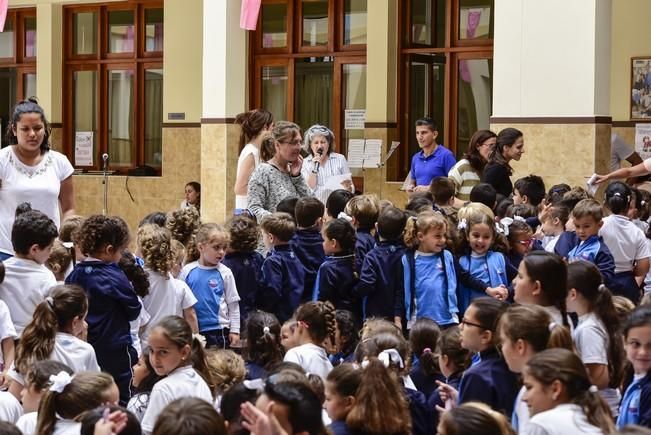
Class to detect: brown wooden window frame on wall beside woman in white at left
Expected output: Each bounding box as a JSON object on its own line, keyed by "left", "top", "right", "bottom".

{"left": 63, "top": 0, "right": 164, "bottom": 175}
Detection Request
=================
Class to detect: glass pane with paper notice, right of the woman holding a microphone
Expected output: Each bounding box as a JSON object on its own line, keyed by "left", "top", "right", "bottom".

{"left": 339, "top": 64, "right": 366, "bottom": 155}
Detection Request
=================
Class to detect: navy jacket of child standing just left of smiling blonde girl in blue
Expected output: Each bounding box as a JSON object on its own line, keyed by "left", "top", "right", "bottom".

{"left": 355, "top": 241, "right": 405, "bottom": 321}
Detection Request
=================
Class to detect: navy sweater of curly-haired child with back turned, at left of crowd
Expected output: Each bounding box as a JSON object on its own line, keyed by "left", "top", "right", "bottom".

{"left": 66, "top": 261, "right": 141, "bottom": 350}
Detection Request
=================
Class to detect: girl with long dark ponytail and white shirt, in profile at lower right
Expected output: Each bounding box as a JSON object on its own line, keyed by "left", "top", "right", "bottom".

{"left": 567, "top": 261, "right": 625, "bottom": 417}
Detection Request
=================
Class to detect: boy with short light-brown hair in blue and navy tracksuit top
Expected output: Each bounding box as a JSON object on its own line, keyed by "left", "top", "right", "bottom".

{"left": 567, "top": 199, "right": 616, "bottom": 290}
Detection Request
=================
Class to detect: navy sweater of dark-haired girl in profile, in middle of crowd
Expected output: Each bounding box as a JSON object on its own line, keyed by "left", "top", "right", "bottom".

{"left": 312, "top": 254, "right": 361, "bottom": 319}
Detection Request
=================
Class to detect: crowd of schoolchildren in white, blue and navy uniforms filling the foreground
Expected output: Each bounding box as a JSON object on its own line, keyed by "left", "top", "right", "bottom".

{"left": 0, "top": 168, "right": 651, "bottom": 435}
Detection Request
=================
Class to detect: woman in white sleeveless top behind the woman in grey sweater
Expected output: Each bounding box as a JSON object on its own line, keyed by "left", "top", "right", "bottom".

{"left": 233, "top": 109, "right": 274, "bottom": 211}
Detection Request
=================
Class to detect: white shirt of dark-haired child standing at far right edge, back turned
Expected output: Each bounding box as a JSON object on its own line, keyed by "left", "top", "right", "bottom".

{"left": 599, "top": 214, "right": 651, "bottom": 273}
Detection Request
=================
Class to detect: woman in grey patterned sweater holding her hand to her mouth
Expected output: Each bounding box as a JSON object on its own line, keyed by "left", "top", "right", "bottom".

{"left": 248, "top": 121, "right": 312, "bottom": 222}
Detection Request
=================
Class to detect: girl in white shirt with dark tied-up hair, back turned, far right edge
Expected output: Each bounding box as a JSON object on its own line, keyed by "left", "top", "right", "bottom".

{"left": 599, "top": 181, "right": 651, "bottom": 303}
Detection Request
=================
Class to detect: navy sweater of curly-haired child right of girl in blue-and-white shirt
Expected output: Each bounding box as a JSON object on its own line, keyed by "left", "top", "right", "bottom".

{"left": 222, "top": 251, "right": 264, "bottom": 325}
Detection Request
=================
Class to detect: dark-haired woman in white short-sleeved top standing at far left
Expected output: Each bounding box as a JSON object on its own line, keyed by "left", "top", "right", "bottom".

{"left": 0, "top": 98, "right": 75, "bottom": 259}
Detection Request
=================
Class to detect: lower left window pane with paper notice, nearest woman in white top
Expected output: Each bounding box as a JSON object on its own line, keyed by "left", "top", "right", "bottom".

{"left": 72, "top": 71, "right": 98, "bottom": 164}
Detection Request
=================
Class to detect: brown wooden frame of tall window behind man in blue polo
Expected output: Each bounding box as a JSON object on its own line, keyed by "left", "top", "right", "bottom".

{"left": 387, "top": 0, "right": 495, "bottom": 181}
